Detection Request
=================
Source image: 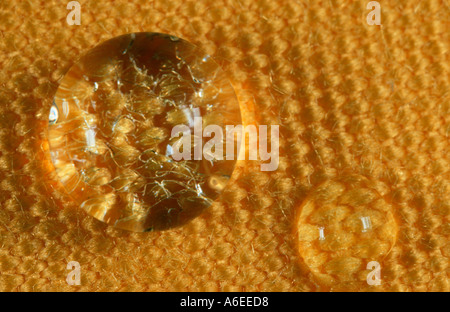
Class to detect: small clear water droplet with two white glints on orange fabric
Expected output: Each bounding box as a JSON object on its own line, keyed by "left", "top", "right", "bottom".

{"left": 297, "top": 175, "right": 397, "bottom": 287}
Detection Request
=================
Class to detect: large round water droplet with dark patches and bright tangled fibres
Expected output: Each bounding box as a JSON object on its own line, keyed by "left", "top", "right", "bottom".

{"left": 49, "top": 33, "right": 241, "bottom": 231}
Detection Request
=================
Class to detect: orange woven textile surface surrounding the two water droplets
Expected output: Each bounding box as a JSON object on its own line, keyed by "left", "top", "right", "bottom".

{"left": 0, "top": 0, "right": 450, "bottom": 291}
